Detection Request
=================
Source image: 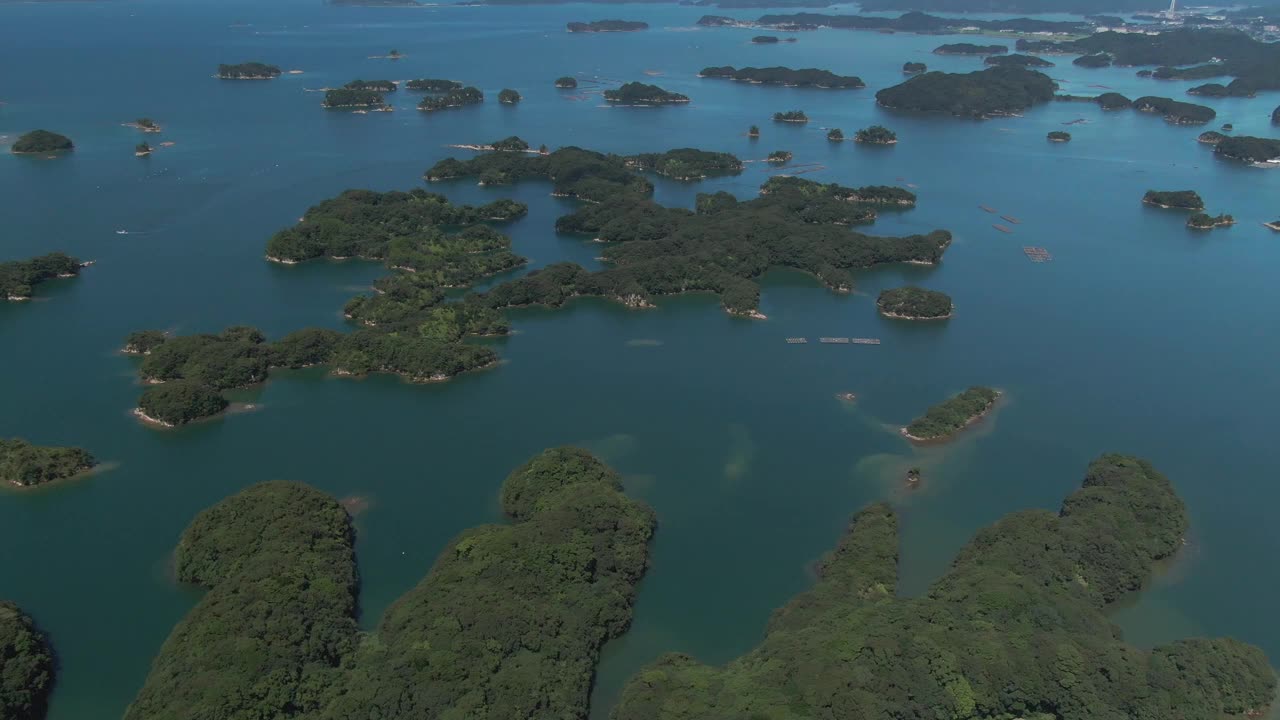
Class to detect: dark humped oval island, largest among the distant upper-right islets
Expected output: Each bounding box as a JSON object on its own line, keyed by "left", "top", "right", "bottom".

{"left": 876, "top": 67, "right": 1057, "bottom": 118}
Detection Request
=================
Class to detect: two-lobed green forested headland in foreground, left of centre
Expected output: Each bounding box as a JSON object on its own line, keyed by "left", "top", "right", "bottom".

{"left": 124, "top": 447, "right": 655, "bottom": 720}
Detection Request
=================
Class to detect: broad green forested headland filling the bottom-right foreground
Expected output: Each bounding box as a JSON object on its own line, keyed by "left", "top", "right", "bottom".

{"left": 612, "top": 455, "right": 1276, "bottom": 720}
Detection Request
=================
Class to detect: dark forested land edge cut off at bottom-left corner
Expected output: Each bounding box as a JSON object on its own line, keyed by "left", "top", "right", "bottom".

{"left": 0, "top": 601, "right": 56, "bottom": 720}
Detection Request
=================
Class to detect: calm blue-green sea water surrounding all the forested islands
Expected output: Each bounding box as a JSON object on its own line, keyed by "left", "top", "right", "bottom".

{"left": 0, "top": 0, "right": 1280, "bottom": 720}
